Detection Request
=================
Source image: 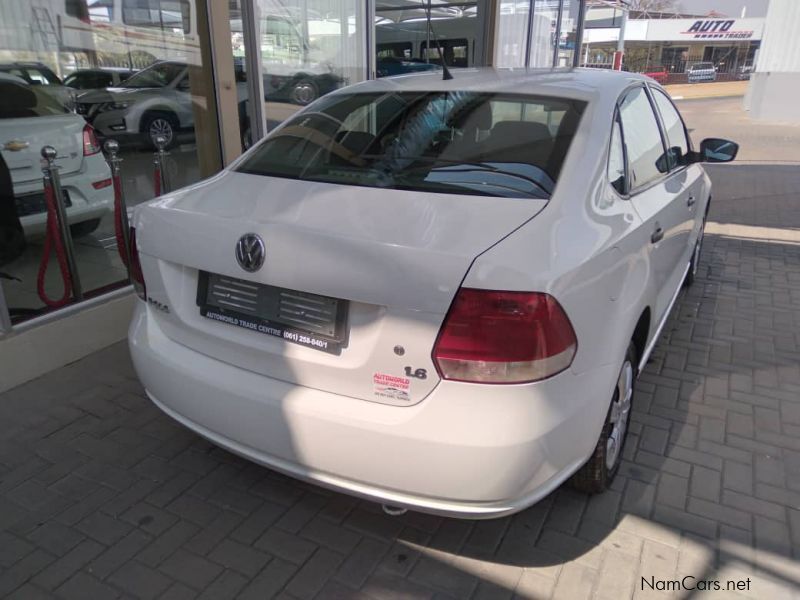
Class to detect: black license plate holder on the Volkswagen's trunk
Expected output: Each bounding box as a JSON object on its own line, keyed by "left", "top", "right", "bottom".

{"left": 197, "top": 271, "right": 349, "bottom": 355}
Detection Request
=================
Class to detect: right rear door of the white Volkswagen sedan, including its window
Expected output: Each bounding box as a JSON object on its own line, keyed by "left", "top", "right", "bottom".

{"left": 619, "top": 84, "right": 686, "bottom": 322}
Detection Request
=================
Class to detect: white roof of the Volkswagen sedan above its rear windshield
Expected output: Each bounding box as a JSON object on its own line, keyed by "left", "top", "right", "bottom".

{"left": 343, "top": 68, "right": 653, "bottom": 102}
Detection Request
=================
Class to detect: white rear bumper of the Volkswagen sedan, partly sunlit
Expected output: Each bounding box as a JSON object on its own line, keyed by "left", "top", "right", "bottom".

{"left": 129, "top": 303, "right": 616, "bottom": 518}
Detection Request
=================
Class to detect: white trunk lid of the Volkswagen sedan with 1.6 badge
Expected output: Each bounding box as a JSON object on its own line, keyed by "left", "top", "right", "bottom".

{"left": 136, "top": 172, "right": 546, "bottom": 405}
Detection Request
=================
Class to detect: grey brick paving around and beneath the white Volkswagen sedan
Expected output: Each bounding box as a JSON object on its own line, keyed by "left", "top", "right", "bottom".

{"left": 0, "top": 166, "right": 800, "bottom": 600}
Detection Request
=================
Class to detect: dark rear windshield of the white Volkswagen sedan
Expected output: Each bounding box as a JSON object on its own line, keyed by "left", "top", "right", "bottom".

{"left": 237, "top": 92, "right": 586, "bottom": 198}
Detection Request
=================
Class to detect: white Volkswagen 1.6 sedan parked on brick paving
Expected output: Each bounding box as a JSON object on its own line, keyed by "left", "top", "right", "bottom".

{"left": 129, "top": 70, "right": 737, "bottom": 518}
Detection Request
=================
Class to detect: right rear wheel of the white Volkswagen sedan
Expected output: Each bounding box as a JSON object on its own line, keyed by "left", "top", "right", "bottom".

{"left": 570, "top": 343, "right": 636, "bottom": 494}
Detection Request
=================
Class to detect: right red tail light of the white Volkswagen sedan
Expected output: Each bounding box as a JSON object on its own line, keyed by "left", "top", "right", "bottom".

{"left": 433, "top": 288, "right": 578, "bottom": 383}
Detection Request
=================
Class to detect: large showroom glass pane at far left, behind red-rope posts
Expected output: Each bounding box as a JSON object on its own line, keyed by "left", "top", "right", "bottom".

{"left": 0, "top": 0, "right": 221, "bottom": 323}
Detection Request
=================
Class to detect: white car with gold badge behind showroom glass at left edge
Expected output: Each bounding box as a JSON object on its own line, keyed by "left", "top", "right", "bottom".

{"left": 0, "top": 76, "right": 114, "bottom": 236}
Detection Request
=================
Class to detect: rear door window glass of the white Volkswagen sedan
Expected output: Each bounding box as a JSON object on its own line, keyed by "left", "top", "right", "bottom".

{"left": 619, "top": 87, "right": 667, "bottom": 190}
